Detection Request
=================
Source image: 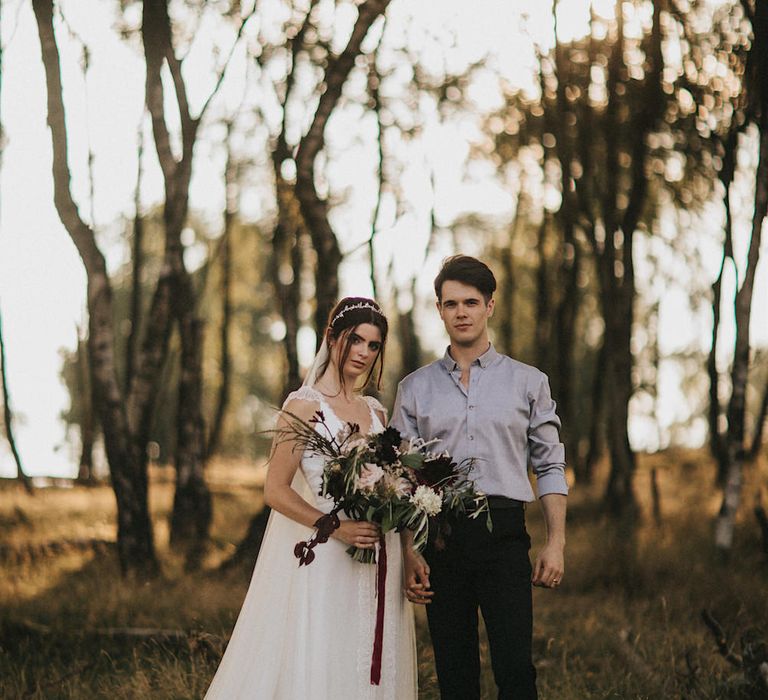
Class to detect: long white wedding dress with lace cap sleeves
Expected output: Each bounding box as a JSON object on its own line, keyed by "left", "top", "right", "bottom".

{"left": 205, "top": 387, "right": 417, "bottom": 700}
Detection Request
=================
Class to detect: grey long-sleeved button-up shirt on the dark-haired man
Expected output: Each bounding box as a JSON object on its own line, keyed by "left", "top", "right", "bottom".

{"left": 390, "top": 345, "right": 568, "bottom": 501}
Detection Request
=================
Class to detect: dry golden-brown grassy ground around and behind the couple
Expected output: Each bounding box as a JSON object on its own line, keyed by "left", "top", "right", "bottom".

{"left": 0, "top": 453, "right": 768, "bottom": 700}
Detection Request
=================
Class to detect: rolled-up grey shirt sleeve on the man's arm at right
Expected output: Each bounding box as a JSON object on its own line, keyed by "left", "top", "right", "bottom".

{"left": 528, "top": 373, "right": 568, "bottom": 498}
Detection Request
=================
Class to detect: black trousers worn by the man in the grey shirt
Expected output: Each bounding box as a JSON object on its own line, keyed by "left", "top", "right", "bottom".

{"left": 425, "top": 507, "right": 537, "bottom": 700}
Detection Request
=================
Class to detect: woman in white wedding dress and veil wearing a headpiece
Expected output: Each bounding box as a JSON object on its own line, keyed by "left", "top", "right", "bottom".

{"left": 205, "top": 297, "right": 417, "bottom": 700}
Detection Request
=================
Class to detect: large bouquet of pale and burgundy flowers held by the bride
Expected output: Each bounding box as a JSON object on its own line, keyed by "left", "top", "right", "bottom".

{"left": 277, "top": 411, "right": 491, "bottom": 566}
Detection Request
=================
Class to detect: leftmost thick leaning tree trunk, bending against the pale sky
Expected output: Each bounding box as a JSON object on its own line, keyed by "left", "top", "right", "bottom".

{"left": 32, "top": 0, "right": 158, "bottom": 577}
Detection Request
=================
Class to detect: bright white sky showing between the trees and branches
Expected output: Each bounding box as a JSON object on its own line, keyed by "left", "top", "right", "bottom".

{"left": 0, "top": 0, "right": 768, "bottom": 475}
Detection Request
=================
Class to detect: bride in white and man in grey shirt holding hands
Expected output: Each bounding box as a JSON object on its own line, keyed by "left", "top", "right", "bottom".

{"left": 205, "top": 255, "right": 568, "bottom": 700}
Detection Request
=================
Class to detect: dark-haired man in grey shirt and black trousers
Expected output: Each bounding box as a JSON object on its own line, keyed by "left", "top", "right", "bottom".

{"left": 391, "top": 255, "right": 568, "bottom": 700}
